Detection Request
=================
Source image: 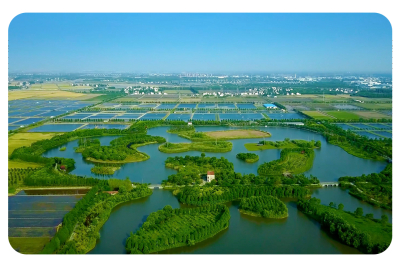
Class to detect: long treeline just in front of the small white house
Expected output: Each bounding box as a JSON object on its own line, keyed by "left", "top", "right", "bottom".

{"left": 174, "top": 185, "right": 311, "bottom": 206}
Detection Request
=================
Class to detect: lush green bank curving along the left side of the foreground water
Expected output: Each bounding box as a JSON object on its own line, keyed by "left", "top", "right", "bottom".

{"left": 42, "top": 185, "right": 152, "bottom": 254}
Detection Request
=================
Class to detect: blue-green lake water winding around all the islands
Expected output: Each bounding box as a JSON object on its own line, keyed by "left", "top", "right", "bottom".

{"left": 44, "top": 126, "right": 392, "bottom": 254}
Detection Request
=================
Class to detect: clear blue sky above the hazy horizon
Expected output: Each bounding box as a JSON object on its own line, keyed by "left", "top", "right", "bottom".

{"left": 9, "top": 13, "right": 392, "bottom": 73}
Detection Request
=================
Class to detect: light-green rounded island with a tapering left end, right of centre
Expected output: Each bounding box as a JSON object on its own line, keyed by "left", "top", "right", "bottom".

{"left": 257, "top": 148, "right": 314, "bottom": 176}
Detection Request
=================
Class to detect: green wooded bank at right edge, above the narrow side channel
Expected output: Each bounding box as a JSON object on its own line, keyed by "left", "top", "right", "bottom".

{"left": 339, "top": 163, "right": 392, "bottom": 210}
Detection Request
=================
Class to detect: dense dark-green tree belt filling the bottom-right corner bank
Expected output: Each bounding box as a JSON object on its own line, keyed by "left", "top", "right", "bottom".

{"left": 297, "top": 198, "right": 391, "bottom": 254}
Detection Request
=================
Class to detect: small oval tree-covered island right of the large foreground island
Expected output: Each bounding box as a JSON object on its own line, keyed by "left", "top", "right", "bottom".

{"left": 239, "top": 196, "right": 289, "bottom": 219}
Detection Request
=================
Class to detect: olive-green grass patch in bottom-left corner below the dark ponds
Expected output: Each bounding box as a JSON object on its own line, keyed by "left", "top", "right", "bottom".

{"left": 8, "top": 237, "right": 51, "bottom": 254}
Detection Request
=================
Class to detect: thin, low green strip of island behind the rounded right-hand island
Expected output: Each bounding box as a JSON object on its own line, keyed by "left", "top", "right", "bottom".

{"left": 244, "top": 138, "right": 321, "bottom": 151}
